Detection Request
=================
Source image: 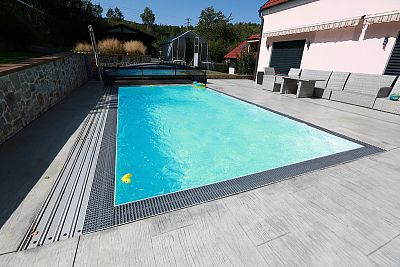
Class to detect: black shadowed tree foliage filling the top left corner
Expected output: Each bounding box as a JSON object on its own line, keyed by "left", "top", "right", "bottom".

{"left": 0, "top": 0, "right": 105, "bottom": 49}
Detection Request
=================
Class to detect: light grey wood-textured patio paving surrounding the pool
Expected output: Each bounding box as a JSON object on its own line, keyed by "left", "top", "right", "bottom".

{"left": 0, "top": 80, "right": 400, "bottom": 266}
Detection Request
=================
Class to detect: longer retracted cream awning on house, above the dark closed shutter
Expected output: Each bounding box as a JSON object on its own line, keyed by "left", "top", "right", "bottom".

{"left": 263, "top": 17, "right": 362, "bottom": 37}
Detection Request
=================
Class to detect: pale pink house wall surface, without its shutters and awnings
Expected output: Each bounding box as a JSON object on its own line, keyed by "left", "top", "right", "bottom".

{"left": 258, "top": 0, "right": 400, "bottom": 74}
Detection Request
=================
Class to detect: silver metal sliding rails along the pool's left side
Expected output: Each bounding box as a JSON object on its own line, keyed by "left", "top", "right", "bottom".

{"left": 19, "top": 88, "right": 111, "bottom": 250}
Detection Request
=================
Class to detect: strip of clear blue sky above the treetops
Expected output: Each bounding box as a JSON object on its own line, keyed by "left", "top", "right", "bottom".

{"left": 98, "top": 0, "right": 266, "bottom": 26}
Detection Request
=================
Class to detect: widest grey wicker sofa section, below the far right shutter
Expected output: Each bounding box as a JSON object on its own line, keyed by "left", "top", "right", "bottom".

{"left": 330, "top": 73, "right": 396, "bottom": 108}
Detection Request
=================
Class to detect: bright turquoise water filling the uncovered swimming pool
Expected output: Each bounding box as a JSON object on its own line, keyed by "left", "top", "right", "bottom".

{"left": 115, "top": 86, "right": 362, "bottom": 205}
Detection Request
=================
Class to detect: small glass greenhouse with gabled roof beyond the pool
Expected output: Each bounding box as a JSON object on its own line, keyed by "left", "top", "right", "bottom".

{"left": 160, "top": 30, "right": 209, "bottom": 67}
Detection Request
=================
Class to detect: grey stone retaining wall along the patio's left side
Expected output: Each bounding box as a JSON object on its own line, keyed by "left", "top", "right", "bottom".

{"left": 0, "top": 54, "right": 87, "bottom": 143}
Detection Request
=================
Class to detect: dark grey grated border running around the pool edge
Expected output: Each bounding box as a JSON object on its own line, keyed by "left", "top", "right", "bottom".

{"left": 83, "top": 88, "right": 384, "bottom": 234}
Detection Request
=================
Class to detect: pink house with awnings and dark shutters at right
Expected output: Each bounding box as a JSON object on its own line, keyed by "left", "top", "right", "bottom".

{"left": 257, "top": 0, "right": 400, "bottom": 75}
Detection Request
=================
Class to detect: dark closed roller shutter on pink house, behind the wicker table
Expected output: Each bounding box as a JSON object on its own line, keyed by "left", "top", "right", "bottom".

{"left": 269, "top": 40, "right": 306, "bottom": 74}
